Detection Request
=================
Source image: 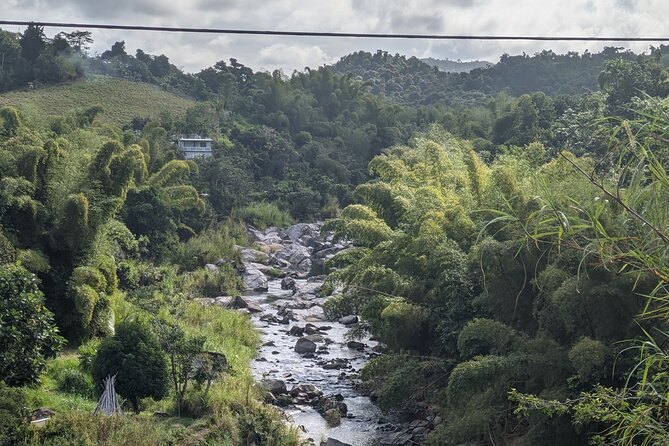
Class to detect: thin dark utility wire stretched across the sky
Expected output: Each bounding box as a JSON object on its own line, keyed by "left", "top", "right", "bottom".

{"left": 0, "top": 20, "right": 669, "bottom": 42}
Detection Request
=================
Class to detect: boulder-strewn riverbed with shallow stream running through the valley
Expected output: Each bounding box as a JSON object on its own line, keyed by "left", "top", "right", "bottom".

{"left": 196, "top": 223, "right": 439, "bottom": 446}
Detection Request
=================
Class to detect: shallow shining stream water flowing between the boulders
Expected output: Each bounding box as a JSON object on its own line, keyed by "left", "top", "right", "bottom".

{"left": 247, "top": 280, "right": 382, "bottom": 446}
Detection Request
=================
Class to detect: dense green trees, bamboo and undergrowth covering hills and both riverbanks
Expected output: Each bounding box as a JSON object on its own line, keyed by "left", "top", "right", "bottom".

{"left": 0, "top": 26, "right": 669, "bottom": 445}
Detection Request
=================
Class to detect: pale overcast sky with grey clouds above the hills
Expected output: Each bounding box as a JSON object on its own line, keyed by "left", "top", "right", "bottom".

{"left": 0, "top": 0, "right": 669, "bottom": 73}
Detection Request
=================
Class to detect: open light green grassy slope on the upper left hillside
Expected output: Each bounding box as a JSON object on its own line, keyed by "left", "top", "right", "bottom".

{"left": 0, "top": 76, "right": 196, "bottom": 126}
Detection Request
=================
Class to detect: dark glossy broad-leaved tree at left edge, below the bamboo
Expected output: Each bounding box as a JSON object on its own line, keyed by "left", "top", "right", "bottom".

{"left": 0, "top": 264, "right": 63, "bottom": 386}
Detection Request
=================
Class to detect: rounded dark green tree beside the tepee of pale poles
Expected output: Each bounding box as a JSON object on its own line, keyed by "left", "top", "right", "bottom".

{"left": 93, "top": 322, "right": 169, "bottom": 412}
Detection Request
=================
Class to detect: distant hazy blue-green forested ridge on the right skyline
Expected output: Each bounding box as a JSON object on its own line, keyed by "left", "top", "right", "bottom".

{"left": 334, "top": 47, "right": 666, "bottom": 106}
